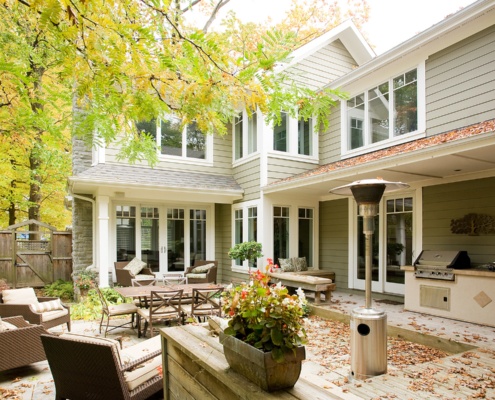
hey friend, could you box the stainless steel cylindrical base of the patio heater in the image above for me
[350,308,387,380]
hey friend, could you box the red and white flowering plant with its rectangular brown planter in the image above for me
[220,260,307,391]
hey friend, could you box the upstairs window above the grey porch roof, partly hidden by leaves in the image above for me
[136,116,209,160]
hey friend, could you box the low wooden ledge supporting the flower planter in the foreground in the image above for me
[160,325,340,400]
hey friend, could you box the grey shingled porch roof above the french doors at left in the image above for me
[71,164,243,193]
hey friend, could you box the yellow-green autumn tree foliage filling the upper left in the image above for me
[0,0,367,230]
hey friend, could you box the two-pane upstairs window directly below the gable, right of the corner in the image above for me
[273,112,317,156]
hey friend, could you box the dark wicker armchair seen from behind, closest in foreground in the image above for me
[41,333,163,400]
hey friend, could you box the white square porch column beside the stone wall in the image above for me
[95,196,110,287]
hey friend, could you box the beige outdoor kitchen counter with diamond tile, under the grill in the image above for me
[401,266,495,326]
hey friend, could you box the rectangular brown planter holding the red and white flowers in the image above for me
[220,332,306,392]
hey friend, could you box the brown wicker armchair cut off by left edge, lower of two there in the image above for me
[0,316,48,371]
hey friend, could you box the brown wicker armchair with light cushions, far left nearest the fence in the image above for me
[0,288,70,331]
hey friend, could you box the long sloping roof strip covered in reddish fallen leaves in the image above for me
[268,119,495,187]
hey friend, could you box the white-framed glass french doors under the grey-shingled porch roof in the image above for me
[115,205,208,272]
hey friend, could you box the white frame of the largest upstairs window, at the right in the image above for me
[340,61,426,158]
